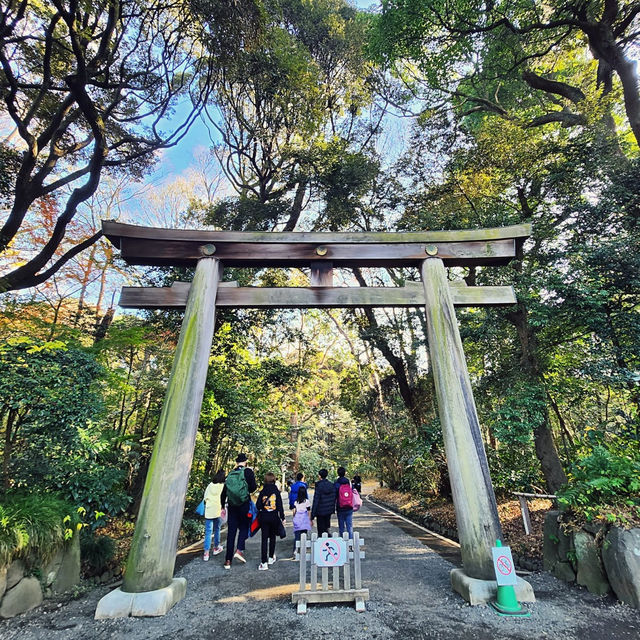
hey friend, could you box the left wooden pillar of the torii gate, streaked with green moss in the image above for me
[122,258,220,593]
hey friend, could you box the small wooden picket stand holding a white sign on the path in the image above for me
[291,531,369,615]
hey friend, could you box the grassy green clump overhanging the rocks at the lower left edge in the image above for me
[0,492,82,566]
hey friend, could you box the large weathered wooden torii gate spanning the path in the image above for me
[96,221,531,618]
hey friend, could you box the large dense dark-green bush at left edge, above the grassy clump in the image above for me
[0,337,130,527]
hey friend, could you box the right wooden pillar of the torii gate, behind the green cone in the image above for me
[422,258,502,580]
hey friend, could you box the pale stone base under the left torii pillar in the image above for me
[94,578,187,620]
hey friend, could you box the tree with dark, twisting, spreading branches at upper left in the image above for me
[0,0,254,292]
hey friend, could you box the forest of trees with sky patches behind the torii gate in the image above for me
[0,0,640,572]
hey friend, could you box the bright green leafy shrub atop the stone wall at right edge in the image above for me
[558,443,640,524]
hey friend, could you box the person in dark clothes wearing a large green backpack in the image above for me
[220,453,257,569]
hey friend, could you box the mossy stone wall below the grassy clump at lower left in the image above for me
[0,535,80,618]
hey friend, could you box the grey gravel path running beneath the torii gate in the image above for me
[0,501,640,640]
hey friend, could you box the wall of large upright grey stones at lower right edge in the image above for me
[543,511,640,609]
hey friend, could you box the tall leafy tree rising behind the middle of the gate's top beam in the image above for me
[202,0,382,231]
